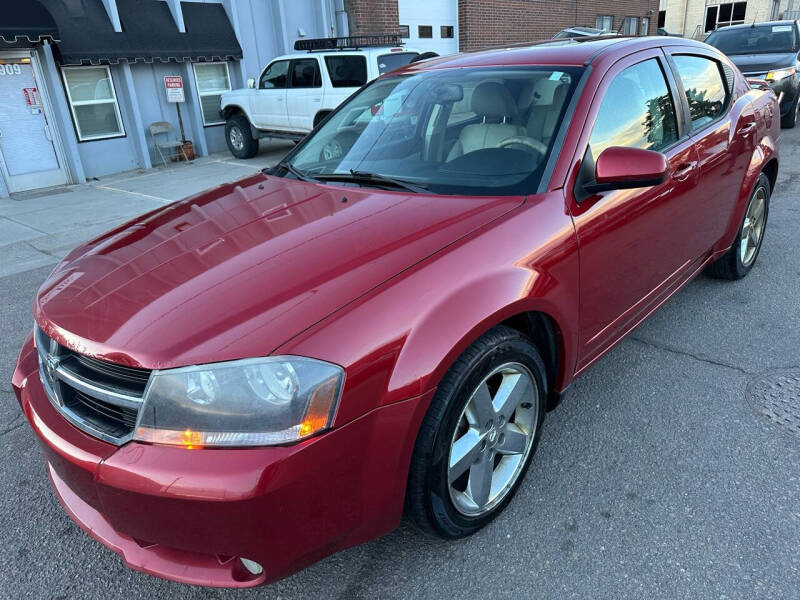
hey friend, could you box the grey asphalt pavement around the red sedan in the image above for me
[0,129,800,600]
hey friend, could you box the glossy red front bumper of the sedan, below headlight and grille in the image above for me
[12,338,433,587]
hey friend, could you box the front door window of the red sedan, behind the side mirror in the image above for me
[589,59,678,159]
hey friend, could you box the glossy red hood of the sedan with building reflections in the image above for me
[35,174,522,368]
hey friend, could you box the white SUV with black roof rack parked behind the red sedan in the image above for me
[220,36,419,158]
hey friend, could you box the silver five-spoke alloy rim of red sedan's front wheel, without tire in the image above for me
[447,363,540,517]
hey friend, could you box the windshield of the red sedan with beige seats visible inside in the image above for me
[278,67,581,195]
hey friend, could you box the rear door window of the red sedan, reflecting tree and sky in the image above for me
[672,56,728,131]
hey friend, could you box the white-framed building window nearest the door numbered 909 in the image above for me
[61,67,125,142]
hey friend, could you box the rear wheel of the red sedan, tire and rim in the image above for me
[707,173,770,279]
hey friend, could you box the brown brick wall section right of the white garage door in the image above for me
[458,0,658,51]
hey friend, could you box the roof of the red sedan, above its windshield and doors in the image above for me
[392,36,708,74]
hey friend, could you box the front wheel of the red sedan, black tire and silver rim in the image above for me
[406,326,547,538]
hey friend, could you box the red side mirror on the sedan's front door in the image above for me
[583,146,669,194]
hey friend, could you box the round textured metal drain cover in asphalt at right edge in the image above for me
[747,369,800,436]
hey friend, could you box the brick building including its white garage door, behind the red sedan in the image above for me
[344,0,659,53]
